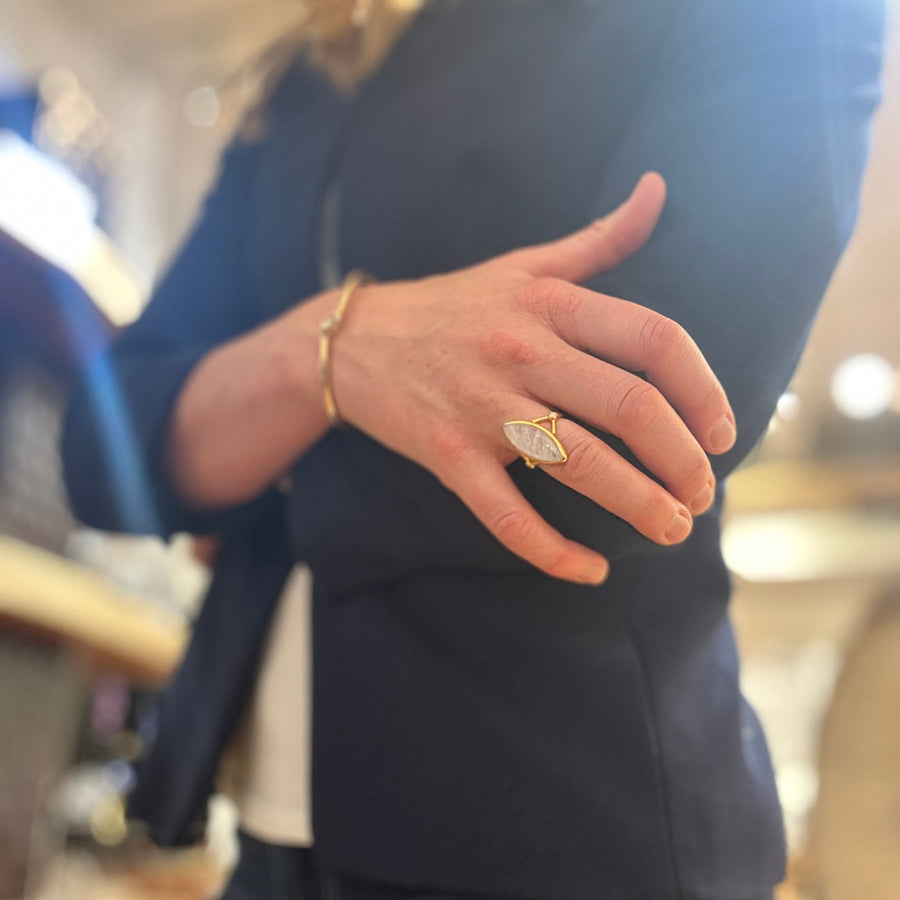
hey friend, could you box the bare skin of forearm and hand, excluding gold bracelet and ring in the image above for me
[167,173,735,583]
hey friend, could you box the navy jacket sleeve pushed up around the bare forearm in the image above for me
[62,142,280,536]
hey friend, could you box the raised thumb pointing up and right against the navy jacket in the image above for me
[507,172,666,284]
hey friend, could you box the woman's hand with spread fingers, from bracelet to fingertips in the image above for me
[326,173,735,583]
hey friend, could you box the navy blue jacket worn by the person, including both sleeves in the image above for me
[64,0,883,900]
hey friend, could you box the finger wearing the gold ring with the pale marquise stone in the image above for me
[500,401,693,546]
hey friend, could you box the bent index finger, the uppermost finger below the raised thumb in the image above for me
[533,281,737,453]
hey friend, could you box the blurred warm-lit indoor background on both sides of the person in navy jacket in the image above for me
[0,0,900,900]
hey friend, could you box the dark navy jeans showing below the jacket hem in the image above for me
[220,833,772,900]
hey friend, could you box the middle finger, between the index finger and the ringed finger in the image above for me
[525,342,715,512]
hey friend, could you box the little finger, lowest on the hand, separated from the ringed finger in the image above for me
[445,453,609,584]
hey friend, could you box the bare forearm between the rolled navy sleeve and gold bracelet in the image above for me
[165,292,335,509]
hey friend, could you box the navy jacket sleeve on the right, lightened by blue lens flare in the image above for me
[515,0,883,556]
